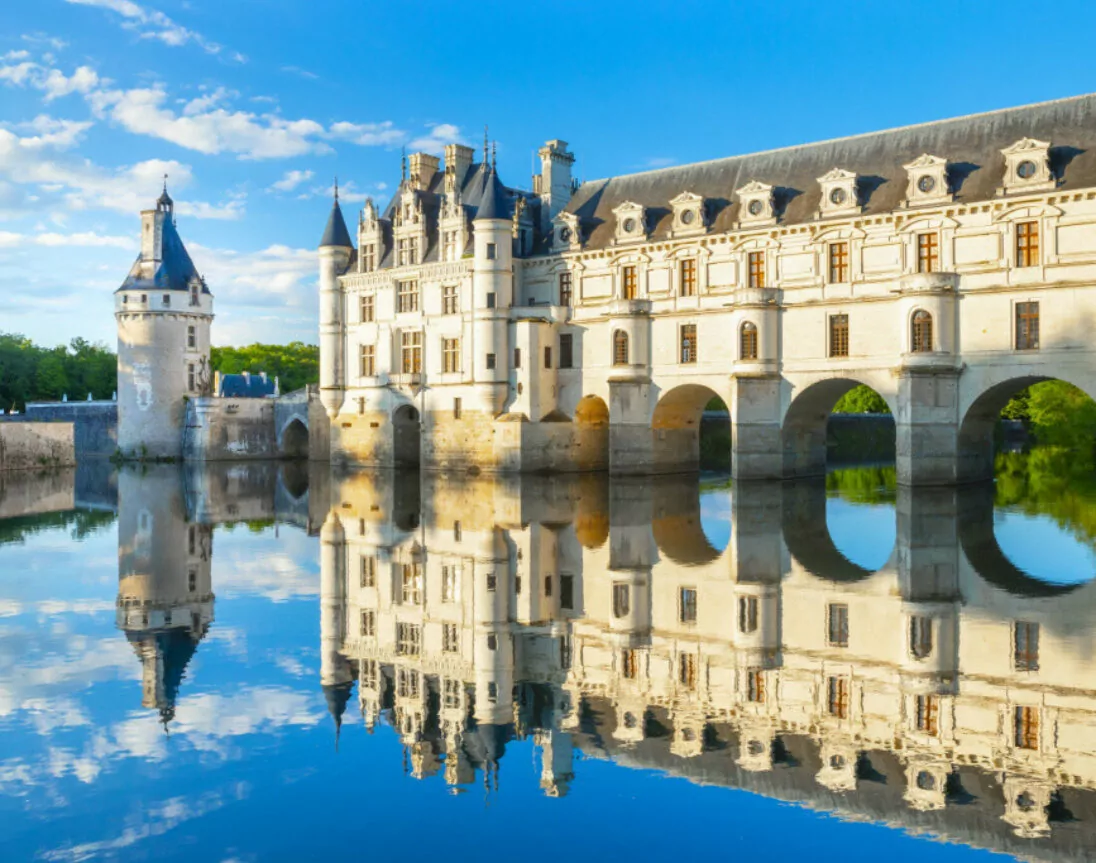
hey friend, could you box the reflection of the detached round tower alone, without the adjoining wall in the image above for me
[117,466,214,724]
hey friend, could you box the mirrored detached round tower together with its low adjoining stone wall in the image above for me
[116,464,320,727]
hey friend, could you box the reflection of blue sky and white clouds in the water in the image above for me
[0,475,1091,861]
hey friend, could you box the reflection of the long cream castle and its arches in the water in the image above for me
[321,475,1096,860]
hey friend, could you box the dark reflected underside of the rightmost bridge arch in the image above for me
[958,482,1093,599]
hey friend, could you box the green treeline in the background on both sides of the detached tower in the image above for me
[0,332,320,411]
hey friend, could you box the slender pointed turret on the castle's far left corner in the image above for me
[320,184,354,419]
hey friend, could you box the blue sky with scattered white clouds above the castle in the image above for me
[0,0,1096,347]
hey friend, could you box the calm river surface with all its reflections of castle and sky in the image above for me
[0,453,1096,863]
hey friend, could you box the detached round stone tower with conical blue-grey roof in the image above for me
[114,184,213,458]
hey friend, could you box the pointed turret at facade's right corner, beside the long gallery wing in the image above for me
[472,164,514,413]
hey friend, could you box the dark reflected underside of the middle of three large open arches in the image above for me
[780,479,894,583]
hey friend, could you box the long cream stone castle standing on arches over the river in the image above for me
[319,95,1096,484]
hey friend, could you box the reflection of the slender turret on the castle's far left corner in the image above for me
[320,512,354,743]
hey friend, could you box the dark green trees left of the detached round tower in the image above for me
[0,332,118,410]
